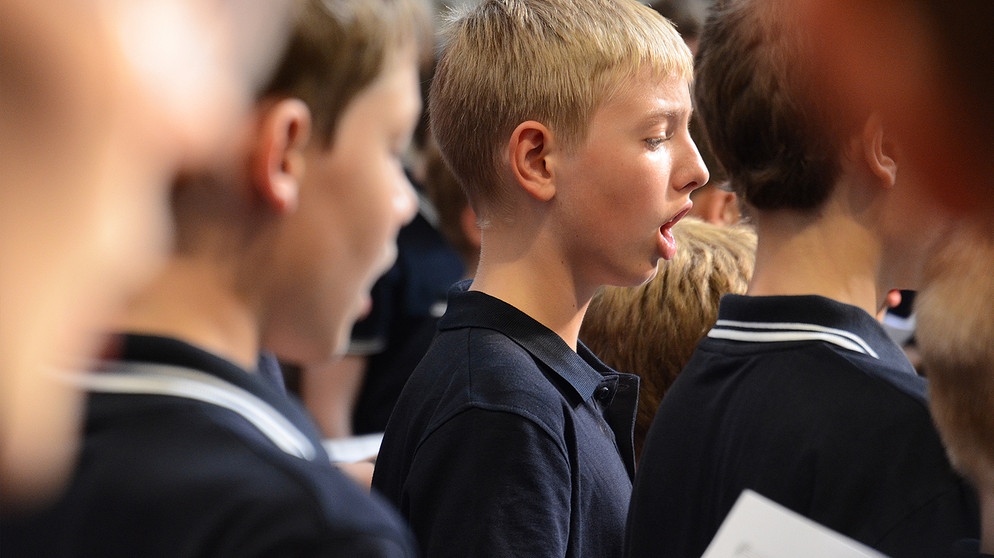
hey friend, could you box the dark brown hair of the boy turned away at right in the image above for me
[694,0,855,210]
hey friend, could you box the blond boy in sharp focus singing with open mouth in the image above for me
[373,0,708,557]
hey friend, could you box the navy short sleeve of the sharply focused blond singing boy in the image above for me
[403,408,573,557]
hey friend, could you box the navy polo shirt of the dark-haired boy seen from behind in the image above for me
[627,295,979,558]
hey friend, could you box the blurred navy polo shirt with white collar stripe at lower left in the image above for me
[2,336,416,557]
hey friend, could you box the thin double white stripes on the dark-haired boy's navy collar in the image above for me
[708,320,880,359]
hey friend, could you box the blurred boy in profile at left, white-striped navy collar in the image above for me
[3,0,426,557]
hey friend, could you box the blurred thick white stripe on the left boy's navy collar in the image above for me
[65,362,317,461]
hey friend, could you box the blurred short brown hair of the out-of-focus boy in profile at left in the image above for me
[262,0,434,147]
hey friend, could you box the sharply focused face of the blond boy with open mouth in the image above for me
[553,71,708,294]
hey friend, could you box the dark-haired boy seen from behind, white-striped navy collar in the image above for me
[629,0,978,557]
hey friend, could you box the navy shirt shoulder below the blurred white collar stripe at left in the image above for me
[16,370,413,556]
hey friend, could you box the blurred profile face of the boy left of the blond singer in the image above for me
[271,52,421,364]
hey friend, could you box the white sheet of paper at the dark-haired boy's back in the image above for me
[702,490,886,558]
